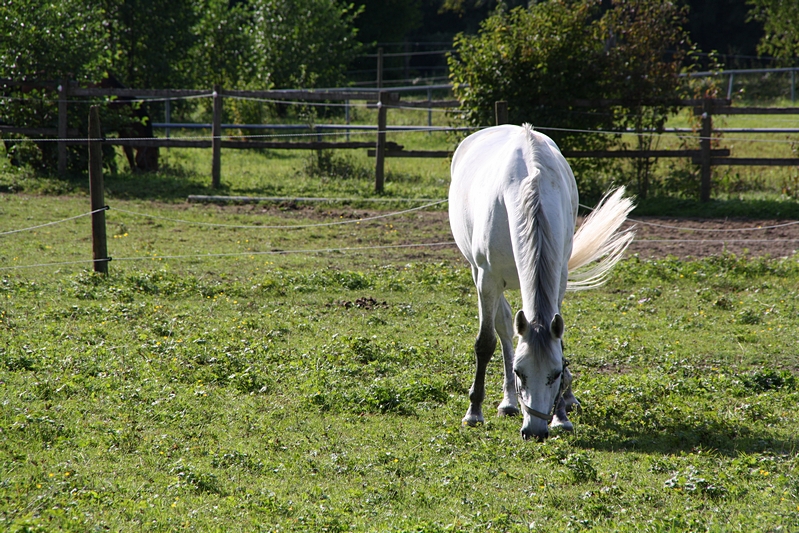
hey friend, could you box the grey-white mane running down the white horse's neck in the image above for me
[518,124,559,343]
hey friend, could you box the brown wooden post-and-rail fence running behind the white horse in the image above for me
[0,80,799,201]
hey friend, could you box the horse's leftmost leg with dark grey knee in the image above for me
[463,271,497,426]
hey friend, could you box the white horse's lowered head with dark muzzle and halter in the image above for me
[513,311,564,440]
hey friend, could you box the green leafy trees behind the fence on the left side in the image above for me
[0,0,358,171]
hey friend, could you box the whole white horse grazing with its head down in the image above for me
[449,124,634,440]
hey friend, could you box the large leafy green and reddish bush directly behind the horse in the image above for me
[449,0,689,196]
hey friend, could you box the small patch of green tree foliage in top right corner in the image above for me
[748,0,799,61]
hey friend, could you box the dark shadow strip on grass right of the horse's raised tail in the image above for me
[632,198,799,219]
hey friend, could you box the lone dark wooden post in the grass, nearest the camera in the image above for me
[89,105,111,274]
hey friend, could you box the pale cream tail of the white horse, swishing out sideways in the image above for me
[566,187,635,291]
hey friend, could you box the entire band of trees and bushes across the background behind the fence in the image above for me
[0,0,799,202]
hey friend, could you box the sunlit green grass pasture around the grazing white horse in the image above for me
[0,192,799,533]
